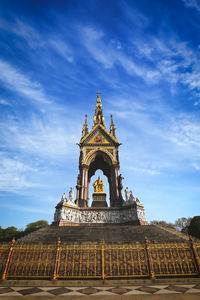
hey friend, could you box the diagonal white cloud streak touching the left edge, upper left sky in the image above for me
[0,59,50,104]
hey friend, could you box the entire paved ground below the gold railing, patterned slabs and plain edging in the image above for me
[0,278,200,300]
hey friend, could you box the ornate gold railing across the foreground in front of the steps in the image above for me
[0,240,200,280]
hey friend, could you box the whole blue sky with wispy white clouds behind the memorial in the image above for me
[0,0,200,228]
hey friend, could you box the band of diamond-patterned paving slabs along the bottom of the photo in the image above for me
[0,283,200,299]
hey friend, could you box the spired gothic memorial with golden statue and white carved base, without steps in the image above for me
[53,92,147,226]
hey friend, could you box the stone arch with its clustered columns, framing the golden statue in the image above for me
[76,149,122,207]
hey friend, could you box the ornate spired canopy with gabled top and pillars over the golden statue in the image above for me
[76,92,123,207]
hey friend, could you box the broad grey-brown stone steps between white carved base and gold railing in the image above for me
[18,225,187,243]
